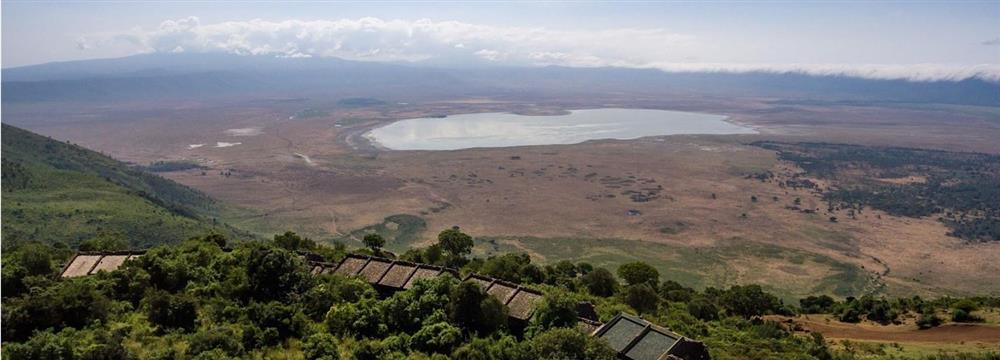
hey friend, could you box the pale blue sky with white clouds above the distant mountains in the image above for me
[0,0,1000,80]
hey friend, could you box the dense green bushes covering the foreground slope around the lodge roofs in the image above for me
[2,230,1000,360]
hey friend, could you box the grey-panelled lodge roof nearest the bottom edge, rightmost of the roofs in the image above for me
[593,313,709,360]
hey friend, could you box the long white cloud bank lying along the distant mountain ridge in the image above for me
[78,17,1000,81]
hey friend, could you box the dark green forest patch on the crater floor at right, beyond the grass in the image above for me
[754,141,1000,241]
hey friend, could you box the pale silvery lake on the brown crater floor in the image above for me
[365,109,756,150]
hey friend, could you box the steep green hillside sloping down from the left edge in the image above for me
[2,124,245,247]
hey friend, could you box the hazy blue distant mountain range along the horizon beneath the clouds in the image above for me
[3,54,1000,106]
